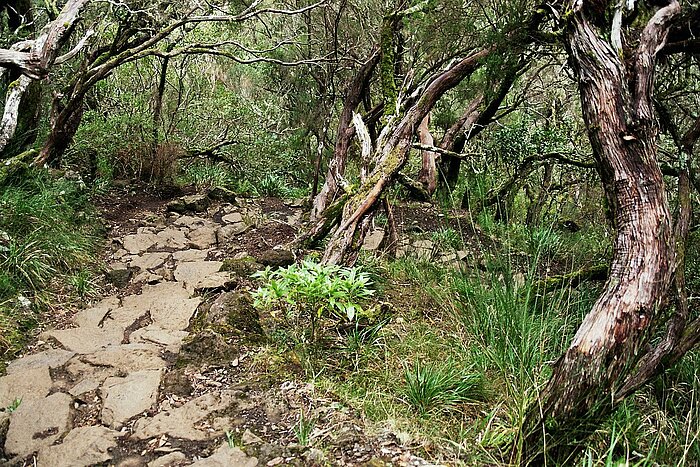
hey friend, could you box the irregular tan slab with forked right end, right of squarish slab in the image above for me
[132,391,235,441]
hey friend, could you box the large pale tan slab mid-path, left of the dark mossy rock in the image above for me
[123,282,201,331]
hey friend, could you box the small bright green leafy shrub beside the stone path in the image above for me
[253,261,374,341]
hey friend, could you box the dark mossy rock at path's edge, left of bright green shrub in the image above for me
[207,292,265,343]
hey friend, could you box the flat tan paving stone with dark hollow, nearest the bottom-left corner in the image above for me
[5,392,73,457]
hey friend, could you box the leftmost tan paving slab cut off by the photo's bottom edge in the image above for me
[37,426,125,467]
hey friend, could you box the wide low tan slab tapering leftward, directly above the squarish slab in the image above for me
[80,344,167,373]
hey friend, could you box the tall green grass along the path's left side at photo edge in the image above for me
[0,170,99,356]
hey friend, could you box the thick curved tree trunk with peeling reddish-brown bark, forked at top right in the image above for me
[514,0,680,464]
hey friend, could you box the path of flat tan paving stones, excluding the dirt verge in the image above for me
[0,192,276,467]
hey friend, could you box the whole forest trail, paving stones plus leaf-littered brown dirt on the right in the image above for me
[0,191,438,467]
